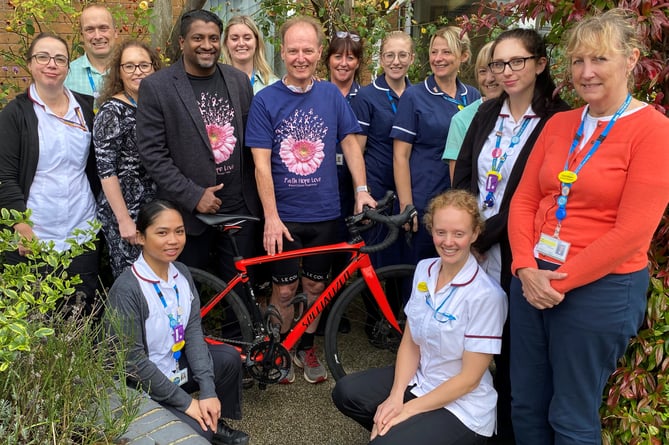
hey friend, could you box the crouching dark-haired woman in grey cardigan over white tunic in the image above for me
[107,200,249,445]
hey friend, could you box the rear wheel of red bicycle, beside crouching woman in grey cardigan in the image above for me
[189,267,254,345]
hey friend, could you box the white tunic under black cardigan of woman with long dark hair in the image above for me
[478,99,540,283]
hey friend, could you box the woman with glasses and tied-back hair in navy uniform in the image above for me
[351,31,414,267]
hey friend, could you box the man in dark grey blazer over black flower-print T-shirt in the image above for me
[137,10,261,288]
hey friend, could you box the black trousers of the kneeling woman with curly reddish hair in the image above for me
[332,366,487,445]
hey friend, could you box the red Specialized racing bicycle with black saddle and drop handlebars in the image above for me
[190,192,416,388]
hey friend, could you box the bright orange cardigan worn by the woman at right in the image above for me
[509,106,669,293]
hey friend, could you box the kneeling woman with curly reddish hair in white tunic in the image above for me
[332,190,507,445]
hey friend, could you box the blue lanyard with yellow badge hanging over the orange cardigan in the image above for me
[553,93,632,234]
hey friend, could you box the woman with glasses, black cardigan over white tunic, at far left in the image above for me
[0,33,100,311]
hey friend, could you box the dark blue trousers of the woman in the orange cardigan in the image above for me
[510,261,648,445]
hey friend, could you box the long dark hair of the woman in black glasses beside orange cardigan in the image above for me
[490,28,561,117]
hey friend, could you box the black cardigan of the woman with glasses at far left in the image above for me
[0,91,101,212]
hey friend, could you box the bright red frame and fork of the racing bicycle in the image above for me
[200,236,401,350]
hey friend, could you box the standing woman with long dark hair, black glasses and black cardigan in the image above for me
[453,29,568,440]
